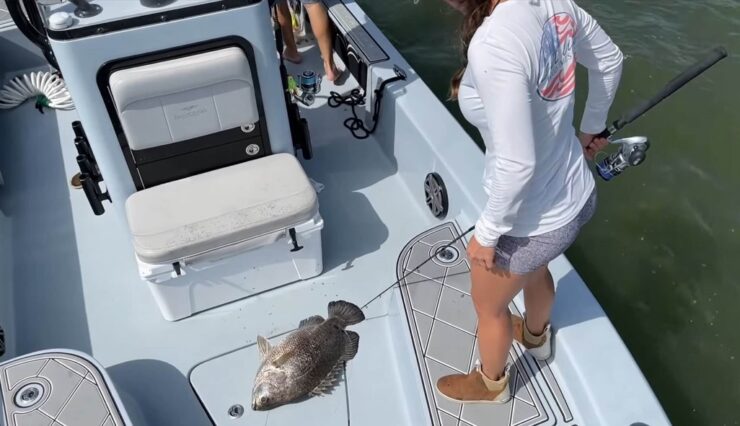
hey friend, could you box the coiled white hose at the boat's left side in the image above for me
[0,71,75,110]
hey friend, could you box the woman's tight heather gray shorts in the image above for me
[495,189,597,275]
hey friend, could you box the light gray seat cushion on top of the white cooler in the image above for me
[126,154,318,264]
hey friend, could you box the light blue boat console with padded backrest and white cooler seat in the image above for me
[21,0,336,320]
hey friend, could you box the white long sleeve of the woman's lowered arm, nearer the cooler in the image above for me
[469,40,535,251]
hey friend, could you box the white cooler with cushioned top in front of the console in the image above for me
[126,154,323,321]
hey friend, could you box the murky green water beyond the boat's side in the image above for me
[361,0,740,425]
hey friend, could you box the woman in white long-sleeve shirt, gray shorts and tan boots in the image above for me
[437,0,622,403]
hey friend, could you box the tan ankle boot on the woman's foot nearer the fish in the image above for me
[437,365,511,404]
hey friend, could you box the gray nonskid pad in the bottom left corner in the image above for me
[0,353,124,426]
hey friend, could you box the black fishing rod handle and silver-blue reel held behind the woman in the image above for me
[596,46,727,182]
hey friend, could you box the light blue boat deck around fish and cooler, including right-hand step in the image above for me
[0,2,663,426]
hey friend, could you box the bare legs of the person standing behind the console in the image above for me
[276,0,340,81]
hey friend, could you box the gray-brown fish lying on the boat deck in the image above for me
[252,300,365,411]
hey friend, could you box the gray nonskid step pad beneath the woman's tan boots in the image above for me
[396,223,574,426]
